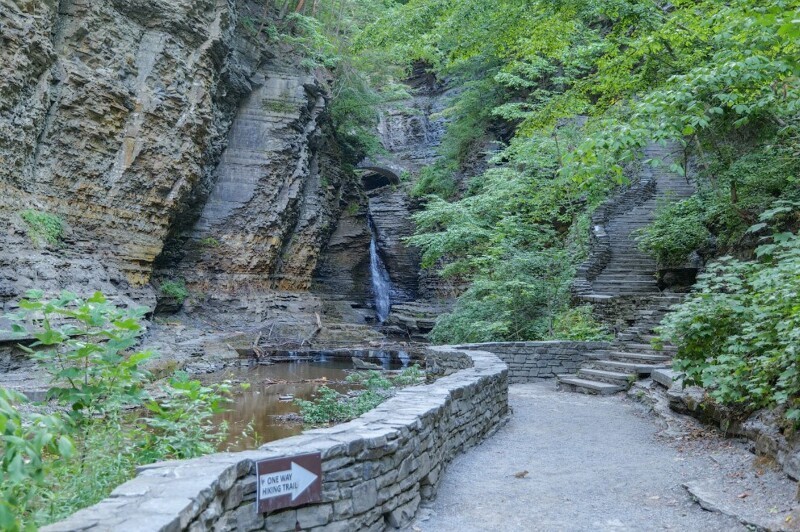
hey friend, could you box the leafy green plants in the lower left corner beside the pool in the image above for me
[0,291,228,530]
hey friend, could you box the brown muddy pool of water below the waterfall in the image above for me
[209,351,419,451]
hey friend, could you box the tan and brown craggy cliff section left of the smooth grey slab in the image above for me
[0,0,250,300]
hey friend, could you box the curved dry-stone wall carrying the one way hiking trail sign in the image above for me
[44,347,509,532]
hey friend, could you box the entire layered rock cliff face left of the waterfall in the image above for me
[0,0,366,314]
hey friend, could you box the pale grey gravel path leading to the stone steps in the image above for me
[409,383,794,532]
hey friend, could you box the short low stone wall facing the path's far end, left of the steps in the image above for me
[458,340,611,384]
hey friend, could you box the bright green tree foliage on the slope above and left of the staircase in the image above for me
[358,0,800,341]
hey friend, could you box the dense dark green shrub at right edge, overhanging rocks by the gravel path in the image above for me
[660,228,800,423]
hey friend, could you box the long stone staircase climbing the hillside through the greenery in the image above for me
[558,145,695,395]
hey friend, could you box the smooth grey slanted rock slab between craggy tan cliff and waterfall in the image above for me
[165,64,366,291]
